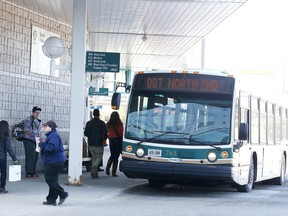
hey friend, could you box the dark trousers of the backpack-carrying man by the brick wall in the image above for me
[23,140,38,175]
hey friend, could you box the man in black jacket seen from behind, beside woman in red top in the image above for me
[84,109,108,178]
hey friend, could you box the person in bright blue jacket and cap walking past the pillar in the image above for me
[39,121,69,206]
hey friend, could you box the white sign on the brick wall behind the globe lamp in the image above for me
[30,26,60,77]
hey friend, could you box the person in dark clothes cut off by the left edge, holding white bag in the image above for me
[0,120,18,194]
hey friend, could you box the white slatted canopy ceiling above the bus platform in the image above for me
[3,0,248,69]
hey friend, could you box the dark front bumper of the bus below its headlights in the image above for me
[120,159,234,183]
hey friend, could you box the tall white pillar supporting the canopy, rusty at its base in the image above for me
[68,0,87,185]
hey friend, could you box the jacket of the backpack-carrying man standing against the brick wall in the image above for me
[24,115,41,142]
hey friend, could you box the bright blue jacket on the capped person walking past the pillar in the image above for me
[39,130,66,167]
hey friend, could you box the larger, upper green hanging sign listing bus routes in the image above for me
[86,51,120,73]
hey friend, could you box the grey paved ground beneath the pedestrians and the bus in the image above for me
[0,148,288,216]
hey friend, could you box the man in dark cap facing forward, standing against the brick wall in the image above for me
[23,106,42,179]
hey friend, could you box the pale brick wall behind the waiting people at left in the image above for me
[0,1,72,172]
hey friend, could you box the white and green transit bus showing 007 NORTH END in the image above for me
[120,71,288,192]
